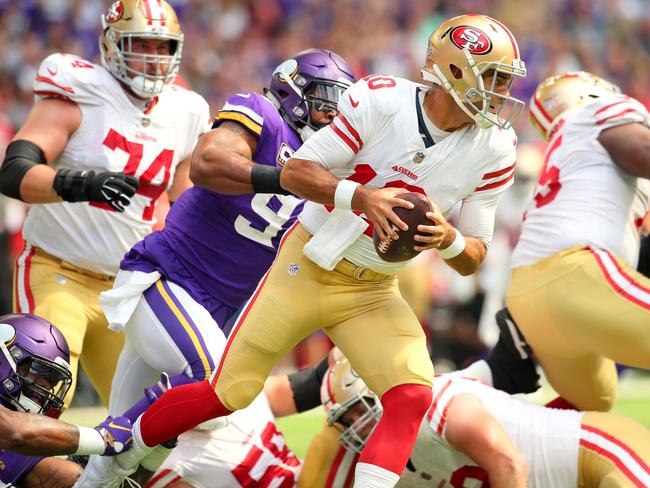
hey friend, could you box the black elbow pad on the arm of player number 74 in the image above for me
[0,140,47,200]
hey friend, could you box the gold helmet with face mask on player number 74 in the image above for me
[99,0,183,98]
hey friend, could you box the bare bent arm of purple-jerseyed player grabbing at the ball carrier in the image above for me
[190,120,260,195]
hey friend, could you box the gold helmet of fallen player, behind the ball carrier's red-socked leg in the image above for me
[320,357,382,453]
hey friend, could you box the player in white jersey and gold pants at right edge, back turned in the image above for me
[506,72,650,411]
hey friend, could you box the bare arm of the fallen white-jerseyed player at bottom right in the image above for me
[446,393,528,488]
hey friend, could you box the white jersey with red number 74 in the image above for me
[23,54,210,275]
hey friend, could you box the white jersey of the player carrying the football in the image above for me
[294,75,517,274]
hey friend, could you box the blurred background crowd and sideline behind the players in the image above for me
[0,0,650,382]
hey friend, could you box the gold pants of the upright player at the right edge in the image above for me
[506,247,650,411]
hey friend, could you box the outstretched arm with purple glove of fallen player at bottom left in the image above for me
[0,407,132,456]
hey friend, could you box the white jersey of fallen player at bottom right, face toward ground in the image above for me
[397,375,582,488]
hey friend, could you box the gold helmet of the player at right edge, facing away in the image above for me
[529,71,621,139]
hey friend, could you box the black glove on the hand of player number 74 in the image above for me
[52,169,138,212]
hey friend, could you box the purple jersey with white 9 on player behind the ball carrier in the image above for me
[120,92,303,327]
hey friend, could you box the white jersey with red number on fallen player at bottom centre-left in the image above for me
[147,393,302,488]
